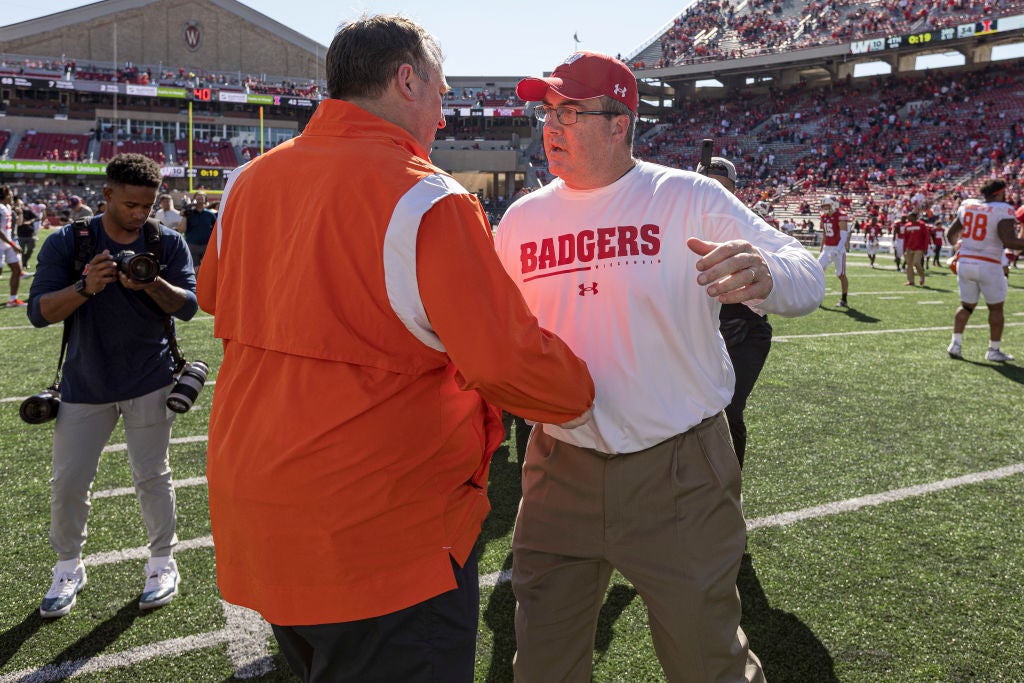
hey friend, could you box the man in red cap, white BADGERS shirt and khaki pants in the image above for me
[496,52,824,682]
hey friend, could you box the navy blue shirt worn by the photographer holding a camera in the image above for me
[28,216,199,403]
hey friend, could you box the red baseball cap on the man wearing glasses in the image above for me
[515,51,640,114]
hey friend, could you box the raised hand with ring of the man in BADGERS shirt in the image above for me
[686,238,772,303]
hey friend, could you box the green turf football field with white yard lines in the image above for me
[0,246,1024,683]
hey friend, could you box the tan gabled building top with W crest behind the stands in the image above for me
[0,0,327,77]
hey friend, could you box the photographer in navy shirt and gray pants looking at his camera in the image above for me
[29,154,198,617]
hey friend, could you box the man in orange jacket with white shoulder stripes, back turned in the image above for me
[199,16,594,682]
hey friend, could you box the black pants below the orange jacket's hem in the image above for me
[273,550,480,683]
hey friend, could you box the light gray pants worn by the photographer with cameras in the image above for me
[50,384,178,560]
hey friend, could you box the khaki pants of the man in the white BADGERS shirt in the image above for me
[512,414,764,683]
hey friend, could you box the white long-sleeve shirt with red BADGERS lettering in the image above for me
[496,162,825,453]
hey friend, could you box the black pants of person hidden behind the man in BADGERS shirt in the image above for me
[722,317,771,467]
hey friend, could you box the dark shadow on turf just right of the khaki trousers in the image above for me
[736,553,839,683]
